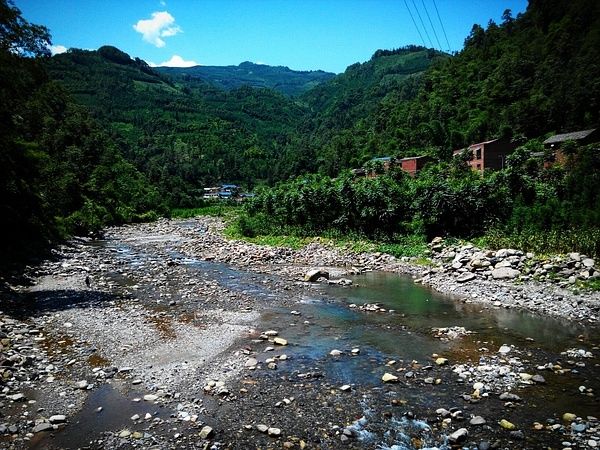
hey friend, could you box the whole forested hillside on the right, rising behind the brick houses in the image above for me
[296,0,600,171]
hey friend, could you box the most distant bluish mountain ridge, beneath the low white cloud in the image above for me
[156,61,335,96]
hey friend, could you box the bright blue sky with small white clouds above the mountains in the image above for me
[15,0,527,73]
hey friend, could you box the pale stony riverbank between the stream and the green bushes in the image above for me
[159,218,600,324]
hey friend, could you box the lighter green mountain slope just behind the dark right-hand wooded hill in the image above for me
[272,46,448,176]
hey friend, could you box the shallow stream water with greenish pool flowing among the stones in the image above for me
[31,239,600,449]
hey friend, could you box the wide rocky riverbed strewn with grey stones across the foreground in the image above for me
[0,218,600,449]
